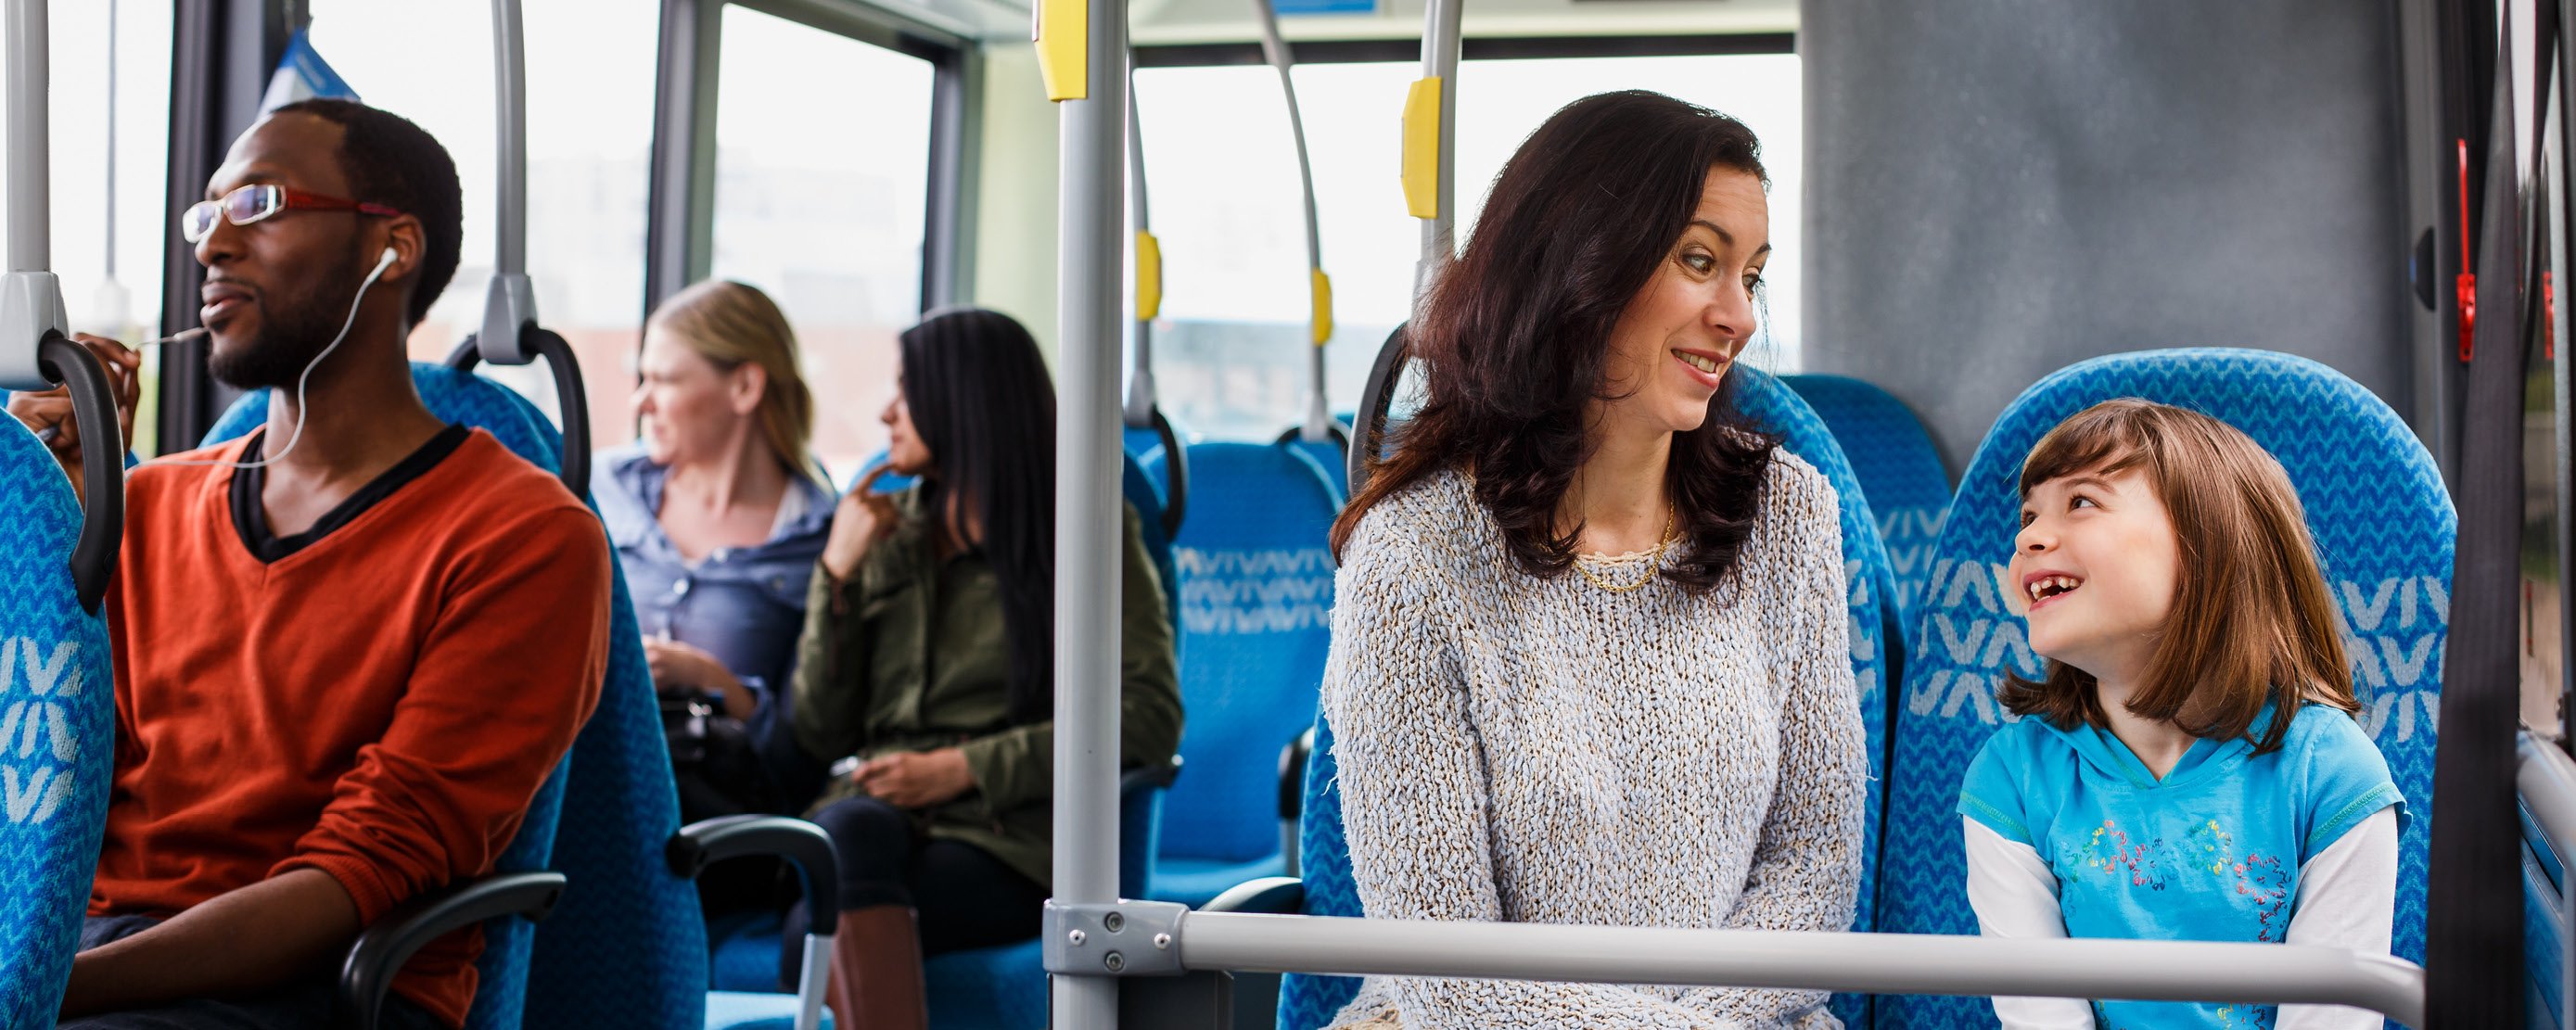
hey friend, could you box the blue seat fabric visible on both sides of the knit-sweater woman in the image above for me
[1278,365,1894,1030]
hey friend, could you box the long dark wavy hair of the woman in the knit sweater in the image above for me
[1332,90,1775,592]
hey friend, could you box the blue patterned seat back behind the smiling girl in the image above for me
[1878,348,2457,1027]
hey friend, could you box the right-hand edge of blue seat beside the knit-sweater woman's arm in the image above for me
[1726,365,1904,1024]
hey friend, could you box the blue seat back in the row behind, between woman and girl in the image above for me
[1780,376,1950,643]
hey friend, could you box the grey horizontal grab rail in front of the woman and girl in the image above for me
[1180,911,2424,1027]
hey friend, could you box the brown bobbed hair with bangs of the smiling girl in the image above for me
[1999,400,2360,755]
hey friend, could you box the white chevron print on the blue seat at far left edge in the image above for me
[0,636,83,824]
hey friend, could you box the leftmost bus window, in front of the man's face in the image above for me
[0,0,174,456]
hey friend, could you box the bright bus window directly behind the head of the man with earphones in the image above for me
[309,0,659,448]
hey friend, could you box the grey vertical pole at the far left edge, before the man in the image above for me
[0,0,64,388]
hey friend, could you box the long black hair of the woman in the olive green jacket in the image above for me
[901,309,1056,723]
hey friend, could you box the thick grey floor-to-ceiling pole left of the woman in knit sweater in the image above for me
[1040,0,1129,1030]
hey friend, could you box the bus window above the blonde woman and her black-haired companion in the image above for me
[711,6,942,481]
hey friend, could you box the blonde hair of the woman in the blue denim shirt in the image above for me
[644,278,822,479]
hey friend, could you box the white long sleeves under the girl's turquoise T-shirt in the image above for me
[1960,806,2398,1030]
